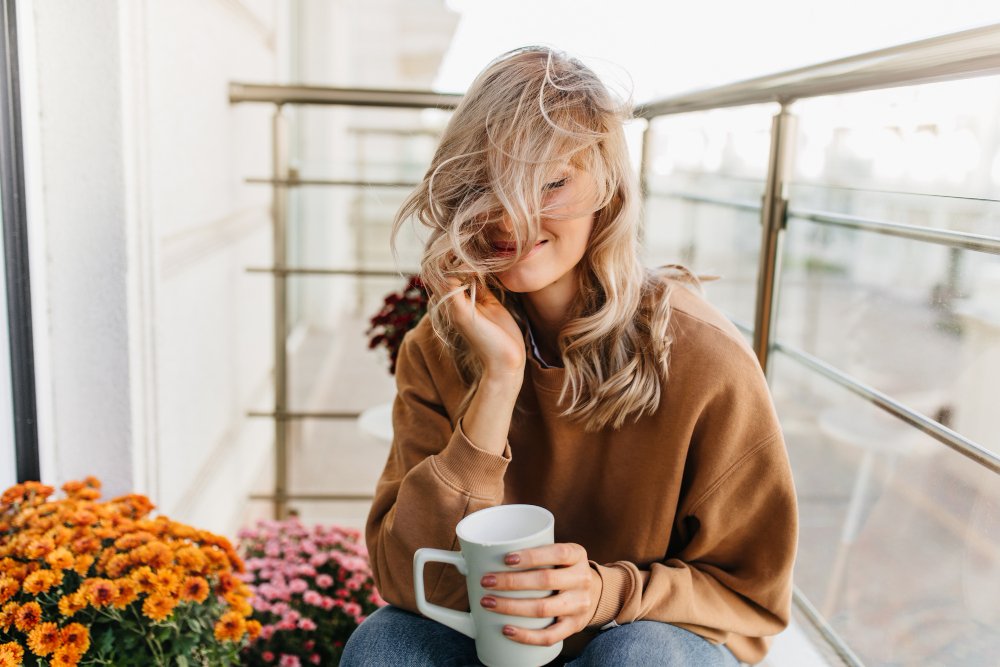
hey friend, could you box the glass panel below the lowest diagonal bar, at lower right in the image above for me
[771,353,1000,667]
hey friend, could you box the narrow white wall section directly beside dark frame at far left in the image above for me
[18,0,133,492]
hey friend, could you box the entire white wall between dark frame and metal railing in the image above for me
[19,0,288,531]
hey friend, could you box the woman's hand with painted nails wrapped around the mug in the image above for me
[480,544,603,646]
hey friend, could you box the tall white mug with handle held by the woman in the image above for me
[413,505,562,667]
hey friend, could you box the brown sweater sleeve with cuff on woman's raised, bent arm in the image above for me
[365,331,510,611]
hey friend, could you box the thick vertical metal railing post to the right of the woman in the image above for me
[753,104,795,376]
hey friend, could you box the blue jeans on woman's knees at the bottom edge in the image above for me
[340,607,739,667]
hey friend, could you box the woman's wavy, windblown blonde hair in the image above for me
[392,47,697,431]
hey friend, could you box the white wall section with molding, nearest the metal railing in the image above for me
[144,0,287,530]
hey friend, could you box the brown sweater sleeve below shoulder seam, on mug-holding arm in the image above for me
[590,431,798,661]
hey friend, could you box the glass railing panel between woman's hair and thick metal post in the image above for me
[643,105,776,332]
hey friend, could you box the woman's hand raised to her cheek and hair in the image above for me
[443,278,525,386]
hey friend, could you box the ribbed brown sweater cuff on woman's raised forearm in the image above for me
[433,420,510,499]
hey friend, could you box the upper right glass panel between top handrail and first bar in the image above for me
[790,76,1000,236]
